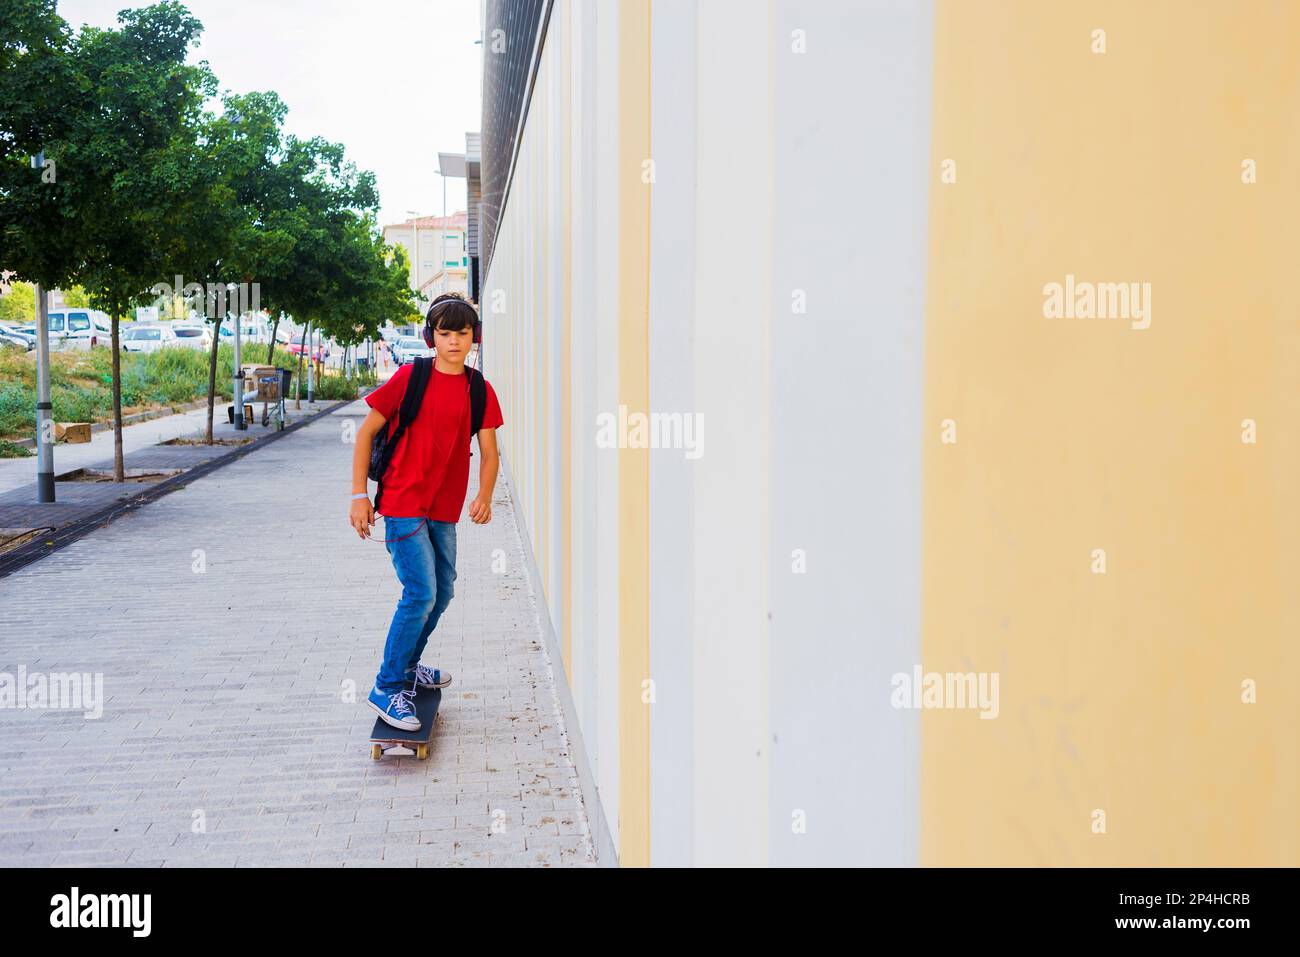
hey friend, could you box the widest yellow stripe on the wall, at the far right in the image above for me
[922,0,1300,866]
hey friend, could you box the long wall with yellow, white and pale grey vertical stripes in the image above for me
[482,0,1300,866]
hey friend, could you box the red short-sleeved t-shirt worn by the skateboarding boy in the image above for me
[365,363,502,521]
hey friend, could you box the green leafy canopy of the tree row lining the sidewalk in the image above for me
[0,0,415,467]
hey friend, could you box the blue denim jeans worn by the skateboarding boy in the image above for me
[374,516,456,694]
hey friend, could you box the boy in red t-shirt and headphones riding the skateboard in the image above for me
[348,293,502,731]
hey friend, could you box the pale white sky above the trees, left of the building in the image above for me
[59,0,481,222]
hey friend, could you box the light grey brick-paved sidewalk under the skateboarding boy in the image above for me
[0,402,594,866]
